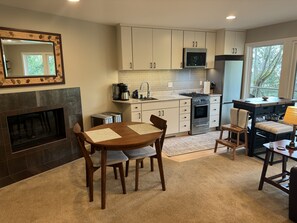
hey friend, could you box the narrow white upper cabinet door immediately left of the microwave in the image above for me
[171,30,184,69]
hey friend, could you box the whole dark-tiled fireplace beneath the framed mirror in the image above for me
[0,88,82,187]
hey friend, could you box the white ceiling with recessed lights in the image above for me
[0,0,297,29]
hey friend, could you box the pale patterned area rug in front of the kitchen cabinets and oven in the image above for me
[162,131,225,157]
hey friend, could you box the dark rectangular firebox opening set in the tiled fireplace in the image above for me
[7,108,66,153]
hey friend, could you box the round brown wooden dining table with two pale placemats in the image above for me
[85,122,166,209]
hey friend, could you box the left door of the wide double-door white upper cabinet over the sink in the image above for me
[132,27,153,70]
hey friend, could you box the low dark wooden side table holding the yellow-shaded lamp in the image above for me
[258,139,297,193]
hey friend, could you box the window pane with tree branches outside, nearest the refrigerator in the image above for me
[249,45,283,97]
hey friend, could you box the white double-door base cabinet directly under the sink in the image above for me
[142,100,179,134]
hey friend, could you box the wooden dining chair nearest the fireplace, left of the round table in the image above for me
[73,123,128,202]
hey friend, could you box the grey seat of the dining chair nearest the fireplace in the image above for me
[90,150,128,167]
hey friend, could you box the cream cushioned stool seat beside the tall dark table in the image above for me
[255,121,293,135]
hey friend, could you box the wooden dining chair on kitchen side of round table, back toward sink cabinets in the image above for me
[123,115,167,191]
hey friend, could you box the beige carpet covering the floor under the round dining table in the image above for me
[0,149,290,223]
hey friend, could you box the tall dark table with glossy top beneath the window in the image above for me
[233,97,296,156]
